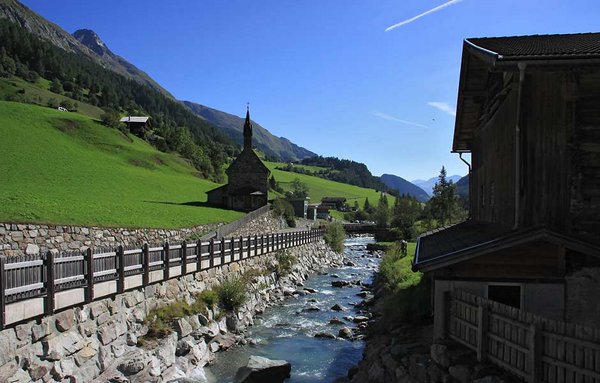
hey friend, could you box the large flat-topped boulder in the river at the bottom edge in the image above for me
[235,355,292,383]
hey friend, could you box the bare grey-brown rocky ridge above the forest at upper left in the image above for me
[0,0,173,98]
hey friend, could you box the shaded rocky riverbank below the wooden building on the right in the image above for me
[346,260,519,383]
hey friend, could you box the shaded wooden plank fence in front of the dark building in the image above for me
[446,290,600,383]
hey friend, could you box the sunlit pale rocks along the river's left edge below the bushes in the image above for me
[86,242,343,383]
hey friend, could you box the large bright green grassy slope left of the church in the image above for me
[0,101,242,228]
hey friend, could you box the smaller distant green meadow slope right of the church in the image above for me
[265,161,394,208]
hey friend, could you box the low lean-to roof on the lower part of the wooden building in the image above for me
[413,221,600,271]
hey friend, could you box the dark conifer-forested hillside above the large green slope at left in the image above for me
[0,19,237,180]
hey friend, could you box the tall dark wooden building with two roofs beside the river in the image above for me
[413,33,600,340]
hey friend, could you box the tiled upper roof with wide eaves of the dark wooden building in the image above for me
[452,33,600,152]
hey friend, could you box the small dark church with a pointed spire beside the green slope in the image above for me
[207,109,271,211]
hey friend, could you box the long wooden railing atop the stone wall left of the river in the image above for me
[0,230,323,329]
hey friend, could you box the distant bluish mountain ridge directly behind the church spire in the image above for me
[184,101,316,162]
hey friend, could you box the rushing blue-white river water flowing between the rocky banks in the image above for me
[206,237,379,383]
